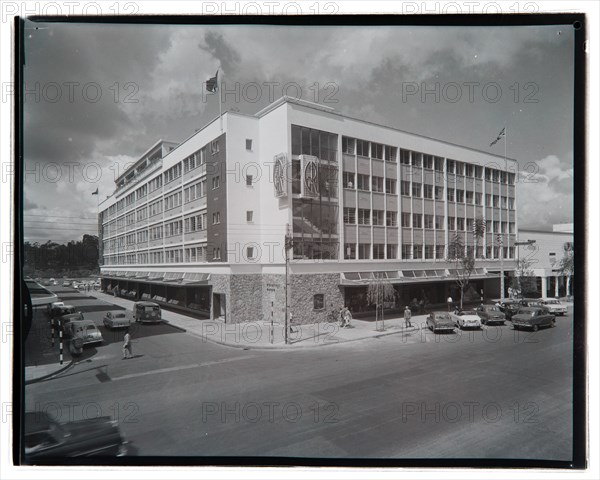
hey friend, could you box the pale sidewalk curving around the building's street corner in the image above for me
[89,292,426,350]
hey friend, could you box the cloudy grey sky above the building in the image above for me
[24,22,574,243]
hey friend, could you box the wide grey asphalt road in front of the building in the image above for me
[25,288,572,460]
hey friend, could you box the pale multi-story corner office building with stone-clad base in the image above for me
[99,97,517,323]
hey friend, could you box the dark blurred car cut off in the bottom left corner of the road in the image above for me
[24,412,128,463]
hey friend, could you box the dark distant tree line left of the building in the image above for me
[23,235,99,276]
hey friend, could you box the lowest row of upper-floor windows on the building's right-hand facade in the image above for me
[344,243,515,260]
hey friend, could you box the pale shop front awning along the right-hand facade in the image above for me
[340,268,499,286]
